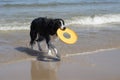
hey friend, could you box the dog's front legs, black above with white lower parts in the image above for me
[46,36,57,56]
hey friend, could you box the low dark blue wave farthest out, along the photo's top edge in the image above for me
[2,1,120,7]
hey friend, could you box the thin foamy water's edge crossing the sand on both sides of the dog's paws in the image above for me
[0,48,120,66]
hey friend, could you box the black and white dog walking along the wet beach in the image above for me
[30,17,65,55]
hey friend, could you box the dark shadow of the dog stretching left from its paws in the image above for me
[15,47,60,62]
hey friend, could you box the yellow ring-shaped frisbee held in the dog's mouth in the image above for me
[57,28,78,44]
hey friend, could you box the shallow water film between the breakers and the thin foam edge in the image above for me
[0,28,120,63]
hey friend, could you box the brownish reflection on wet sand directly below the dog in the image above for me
[31,61,60,80]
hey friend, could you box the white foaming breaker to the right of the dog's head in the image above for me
[66,14,120,25]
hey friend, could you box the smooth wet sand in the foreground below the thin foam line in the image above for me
[0,49,120,80]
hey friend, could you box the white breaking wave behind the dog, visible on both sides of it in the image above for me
[0,14,120,30]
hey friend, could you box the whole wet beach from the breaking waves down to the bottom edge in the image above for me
[0,28,120,80]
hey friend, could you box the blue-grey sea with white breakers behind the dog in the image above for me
[0,0,120,31]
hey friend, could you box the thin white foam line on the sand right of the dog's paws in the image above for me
[63,48,118,57]
